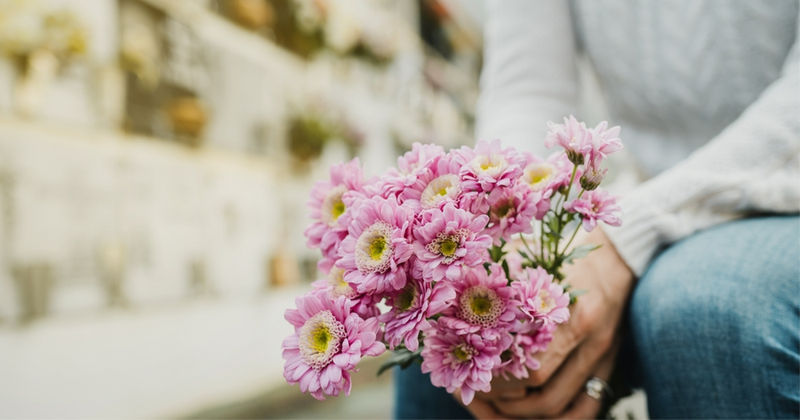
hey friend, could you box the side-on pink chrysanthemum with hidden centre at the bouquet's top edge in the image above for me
[380,143,445,198]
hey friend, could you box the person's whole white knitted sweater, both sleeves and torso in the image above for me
[477,0,800,275]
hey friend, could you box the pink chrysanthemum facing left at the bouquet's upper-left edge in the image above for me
[305,158,364,273]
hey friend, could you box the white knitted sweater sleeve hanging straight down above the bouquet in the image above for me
[476,0,578,156]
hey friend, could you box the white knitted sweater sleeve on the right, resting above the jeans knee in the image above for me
[604,17,800,275]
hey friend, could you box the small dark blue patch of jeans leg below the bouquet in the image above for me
[393,365,473,420]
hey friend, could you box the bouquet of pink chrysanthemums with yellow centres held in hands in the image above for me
[283,117,622,404]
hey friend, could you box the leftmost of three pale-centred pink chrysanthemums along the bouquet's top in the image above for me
[398,153,462,211]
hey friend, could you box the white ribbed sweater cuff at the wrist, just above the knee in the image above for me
[603,200,664,277]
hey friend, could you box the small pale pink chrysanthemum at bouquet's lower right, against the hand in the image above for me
[510,267,569,325]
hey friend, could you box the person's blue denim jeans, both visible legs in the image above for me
[395,216,800,420]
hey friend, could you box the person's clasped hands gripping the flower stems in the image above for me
[460,228,634,420]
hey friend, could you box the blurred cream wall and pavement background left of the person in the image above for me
[0,0,482,420]
